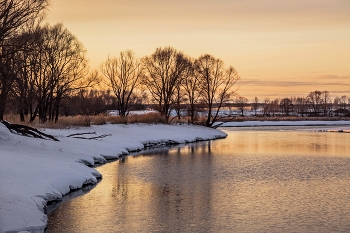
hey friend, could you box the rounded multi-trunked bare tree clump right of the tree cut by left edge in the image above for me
[14,24,91,123]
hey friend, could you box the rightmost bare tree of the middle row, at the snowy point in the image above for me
[194,54,240,127]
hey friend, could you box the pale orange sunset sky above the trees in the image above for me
[47,0,350,101]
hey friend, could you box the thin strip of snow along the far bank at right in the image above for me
[216,121,350,127]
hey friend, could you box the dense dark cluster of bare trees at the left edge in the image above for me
[0,0,98,122]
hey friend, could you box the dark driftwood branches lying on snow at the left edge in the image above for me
[1,121,59,141]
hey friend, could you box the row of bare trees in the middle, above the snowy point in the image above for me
[100,47,239,126]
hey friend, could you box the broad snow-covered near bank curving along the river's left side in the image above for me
[0,123,226,232]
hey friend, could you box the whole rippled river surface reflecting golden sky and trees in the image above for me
[48,127,350,232]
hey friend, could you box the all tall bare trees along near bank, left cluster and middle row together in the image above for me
[0,0,243,126]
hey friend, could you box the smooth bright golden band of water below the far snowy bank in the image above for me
[219,131,350,157]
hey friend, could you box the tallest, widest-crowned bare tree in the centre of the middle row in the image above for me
[142,47,191,121]
